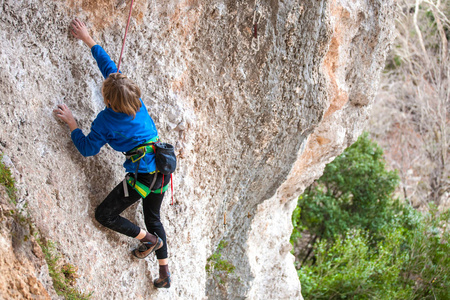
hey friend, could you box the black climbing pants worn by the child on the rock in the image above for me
[95,173,170,259]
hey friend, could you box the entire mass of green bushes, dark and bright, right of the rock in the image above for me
[291,134,450,300]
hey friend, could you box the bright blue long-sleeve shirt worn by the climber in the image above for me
[71,45,158,173]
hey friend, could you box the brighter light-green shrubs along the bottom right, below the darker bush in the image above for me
[298,208,450,300]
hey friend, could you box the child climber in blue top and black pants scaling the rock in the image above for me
[54,19,170,288]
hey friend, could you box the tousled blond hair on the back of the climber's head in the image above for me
[102,73,142,119]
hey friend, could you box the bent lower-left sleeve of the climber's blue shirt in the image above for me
[71,120,107,157]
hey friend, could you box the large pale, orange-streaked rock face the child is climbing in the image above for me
[0,0,393,299]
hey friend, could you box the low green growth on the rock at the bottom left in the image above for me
[38,239,92,300]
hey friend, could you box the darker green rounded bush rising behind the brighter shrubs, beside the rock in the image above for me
[293,133,402,243]
